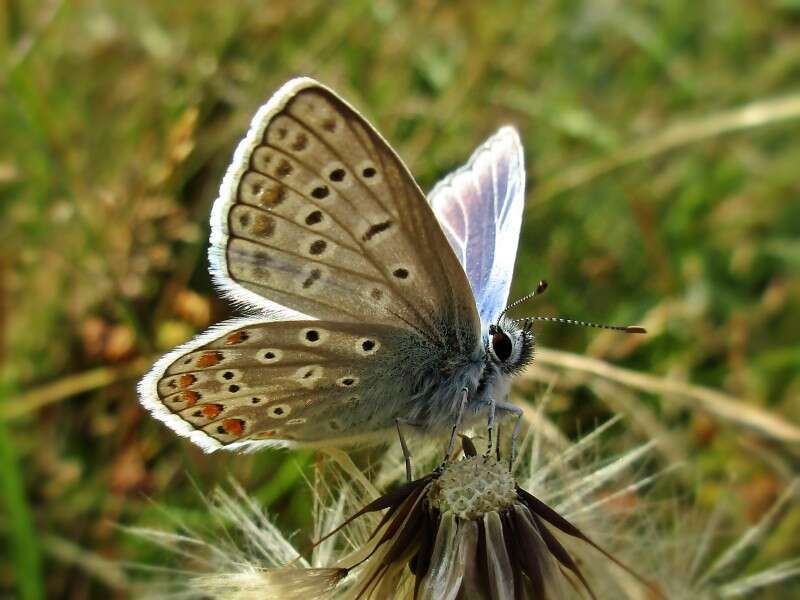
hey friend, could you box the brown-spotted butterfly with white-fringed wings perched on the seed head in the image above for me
[138,78,644,452]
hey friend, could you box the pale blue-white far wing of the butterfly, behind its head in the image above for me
[429,127,525,326]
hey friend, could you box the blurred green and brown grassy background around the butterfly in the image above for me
[0,0,800,598]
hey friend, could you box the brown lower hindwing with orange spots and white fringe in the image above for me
[140,319,406,451]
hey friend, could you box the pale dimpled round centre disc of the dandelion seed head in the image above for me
[428,456,517,519]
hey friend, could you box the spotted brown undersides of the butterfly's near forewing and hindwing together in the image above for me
[139,78,480,451]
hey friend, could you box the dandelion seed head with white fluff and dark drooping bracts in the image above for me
[128,421,800,600]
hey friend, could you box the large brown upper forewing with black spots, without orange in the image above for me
[212,80,479,335]
